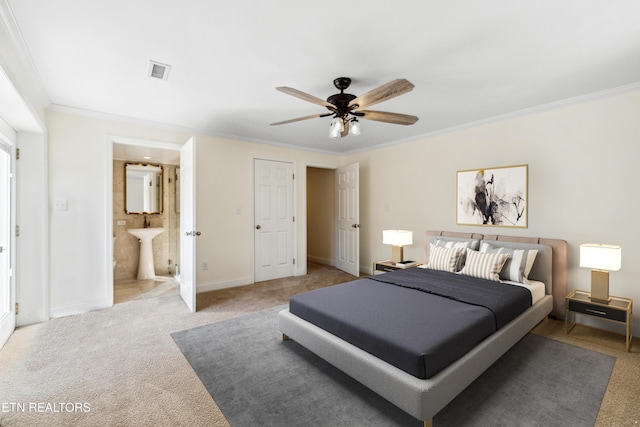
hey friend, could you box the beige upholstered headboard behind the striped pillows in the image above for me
[424,230,568,319]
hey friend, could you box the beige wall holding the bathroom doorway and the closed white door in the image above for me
[47,107,340,317]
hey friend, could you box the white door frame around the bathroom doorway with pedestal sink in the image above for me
[104,135,182,307]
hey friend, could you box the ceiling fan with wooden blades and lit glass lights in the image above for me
[271,77,418,138]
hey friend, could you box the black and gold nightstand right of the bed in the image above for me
[564,290,633,351]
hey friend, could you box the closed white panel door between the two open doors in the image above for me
[253,159,295,282]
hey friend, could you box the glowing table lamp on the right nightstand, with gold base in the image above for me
[580,243,622,304]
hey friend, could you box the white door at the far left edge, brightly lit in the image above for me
[0,141,16,348]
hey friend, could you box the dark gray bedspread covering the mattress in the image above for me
[289,268,531,378]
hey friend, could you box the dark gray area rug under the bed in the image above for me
[171,306,615,427]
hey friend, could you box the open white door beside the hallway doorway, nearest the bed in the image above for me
[336,163,360,277]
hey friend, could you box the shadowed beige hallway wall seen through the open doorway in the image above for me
[307,167,336,265]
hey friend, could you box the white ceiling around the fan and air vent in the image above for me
[1,0,640,153]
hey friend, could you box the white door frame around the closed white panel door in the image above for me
[249,155,298,283]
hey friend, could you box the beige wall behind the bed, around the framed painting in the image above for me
[347,90,640,330]
